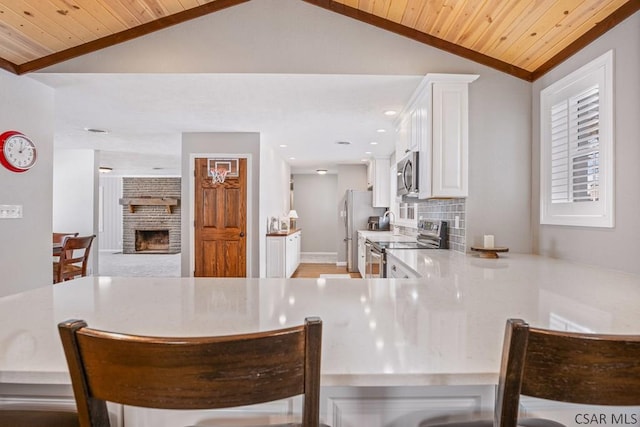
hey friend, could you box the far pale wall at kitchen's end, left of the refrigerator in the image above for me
[293,174,338,253]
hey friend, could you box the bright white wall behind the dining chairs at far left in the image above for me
[52,150,100,275]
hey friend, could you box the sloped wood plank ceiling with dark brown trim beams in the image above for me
[0,0,640,81]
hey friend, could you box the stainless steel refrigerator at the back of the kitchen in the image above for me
[343,190,386,272]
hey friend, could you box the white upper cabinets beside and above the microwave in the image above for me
[396,74,478,199]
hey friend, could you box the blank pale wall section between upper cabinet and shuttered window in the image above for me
[465,73,532,253]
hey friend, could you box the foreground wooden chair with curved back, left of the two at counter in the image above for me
[58,317,330,427]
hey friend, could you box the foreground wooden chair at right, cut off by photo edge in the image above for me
[420,319,640,427]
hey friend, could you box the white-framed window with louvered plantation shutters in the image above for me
[540,51,614,227]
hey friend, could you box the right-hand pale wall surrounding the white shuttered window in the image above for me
[532,12,640,276]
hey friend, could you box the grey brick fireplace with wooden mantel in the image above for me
[120,177,181,254]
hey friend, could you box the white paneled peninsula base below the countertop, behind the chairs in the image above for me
[11,383,639,427]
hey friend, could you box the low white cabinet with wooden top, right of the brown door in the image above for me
[267,230,302,278]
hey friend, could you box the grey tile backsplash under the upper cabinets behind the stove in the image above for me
[418,199,467,253]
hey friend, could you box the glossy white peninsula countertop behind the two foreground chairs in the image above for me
[0,254,640,387]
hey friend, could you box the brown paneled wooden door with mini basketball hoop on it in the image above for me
[194,159,247,277]
